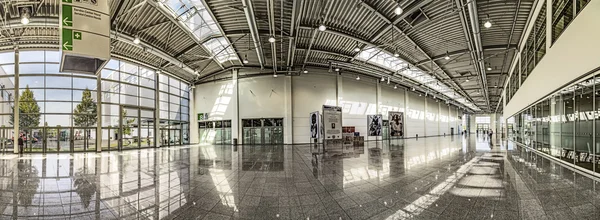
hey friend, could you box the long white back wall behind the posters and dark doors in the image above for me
[196,70,460,144]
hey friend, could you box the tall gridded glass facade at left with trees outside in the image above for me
[0,51,189,152]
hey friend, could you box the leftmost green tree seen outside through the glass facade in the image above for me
[9,86,41,152]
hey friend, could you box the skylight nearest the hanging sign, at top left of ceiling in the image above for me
[164,0,238,63]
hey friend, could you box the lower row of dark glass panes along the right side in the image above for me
[507,73,600,172]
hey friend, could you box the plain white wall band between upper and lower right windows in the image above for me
[504,1,600,118]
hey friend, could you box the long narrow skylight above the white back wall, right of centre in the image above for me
[358,48,480,111]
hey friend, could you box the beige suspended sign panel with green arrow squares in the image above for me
[60,0,110,74]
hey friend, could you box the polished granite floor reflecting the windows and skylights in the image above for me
[0,135,600,220]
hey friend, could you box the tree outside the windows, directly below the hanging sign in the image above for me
[73,88,98,150]
